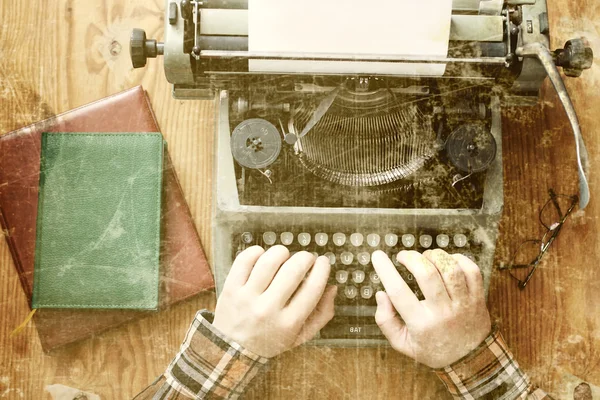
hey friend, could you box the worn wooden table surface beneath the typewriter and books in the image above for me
[0,0,600,399]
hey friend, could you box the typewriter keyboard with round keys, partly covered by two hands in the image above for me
[233,231,480,339]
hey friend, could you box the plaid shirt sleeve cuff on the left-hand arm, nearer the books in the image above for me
[135,310,268,400]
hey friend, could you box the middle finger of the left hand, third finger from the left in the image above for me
[264,251,315,308]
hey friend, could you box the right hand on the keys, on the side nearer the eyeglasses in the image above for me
[372,249,491,368]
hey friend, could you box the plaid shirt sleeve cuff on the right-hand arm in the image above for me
[435,329,552,400]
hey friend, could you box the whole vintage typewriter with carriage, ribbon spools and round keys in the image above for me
[131,0,593,346]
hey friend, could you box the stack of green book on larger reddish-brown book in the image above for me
[0,86,214,351]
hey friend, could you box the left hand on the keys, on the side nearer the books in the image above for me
[213,246,337,358]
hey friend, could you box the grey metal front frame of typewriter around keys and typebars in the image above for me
[212,90,503,347]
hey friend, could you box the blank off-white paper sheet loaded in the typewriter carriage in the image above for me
[248,0,452,76]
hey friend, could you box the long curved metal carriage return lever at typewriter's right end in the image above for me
[515,43,590,210]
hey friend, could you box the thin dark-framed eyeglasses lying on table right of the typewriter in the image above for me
[498,189,579,290]
